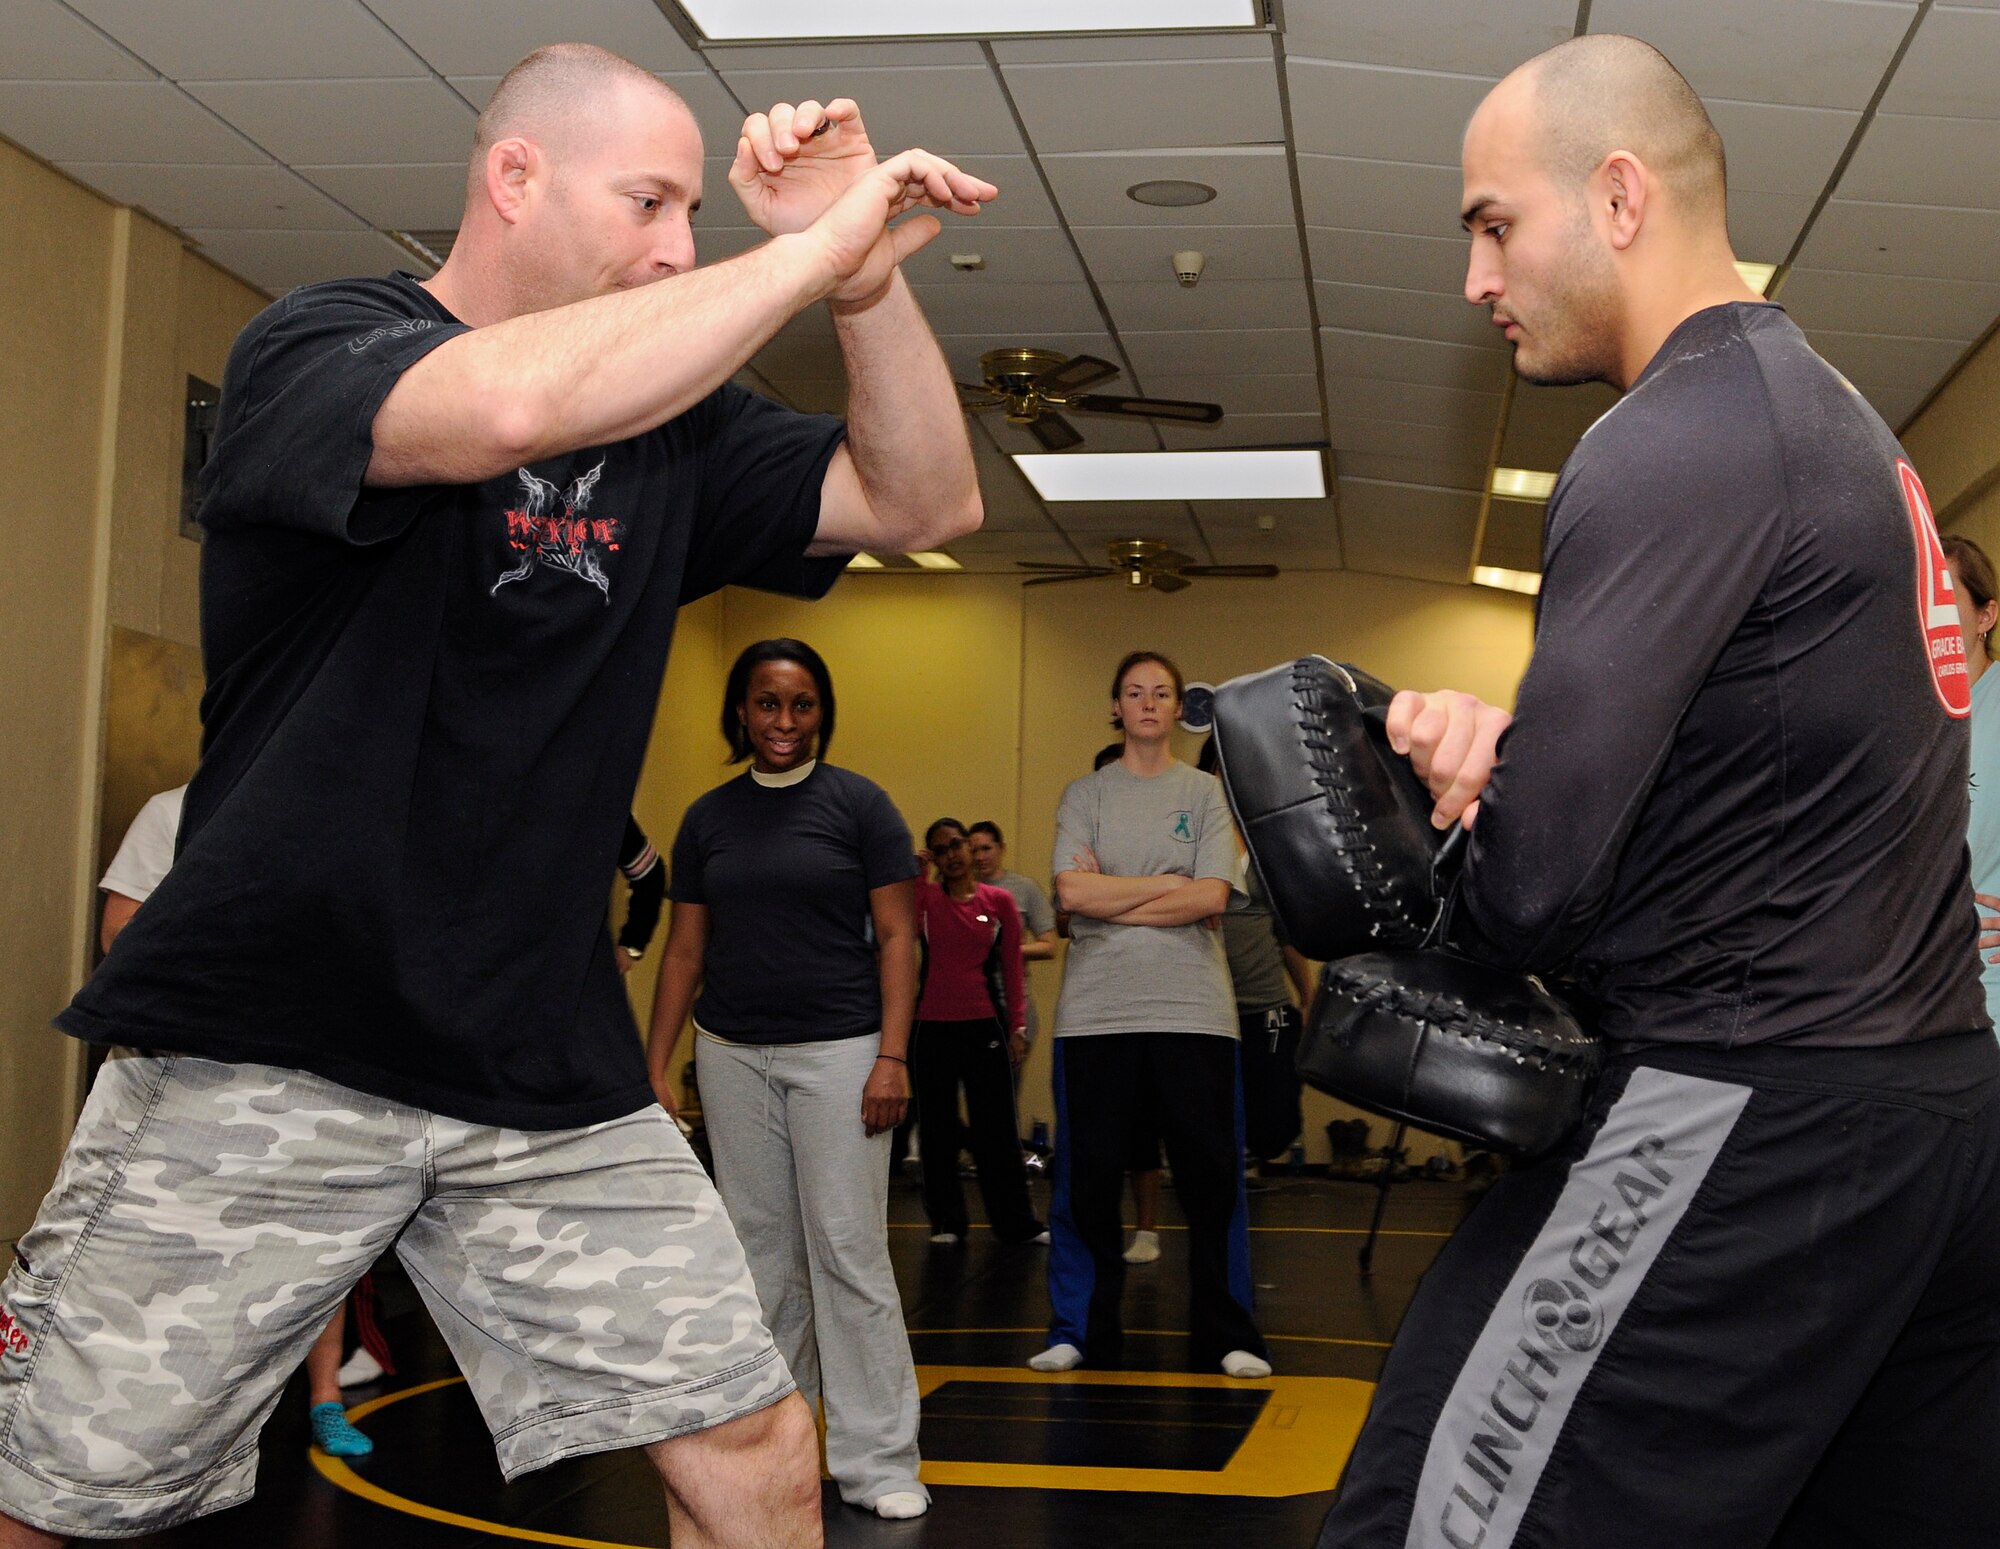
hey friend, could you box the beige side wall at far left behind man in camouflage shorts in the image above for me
[0,142,264,1243]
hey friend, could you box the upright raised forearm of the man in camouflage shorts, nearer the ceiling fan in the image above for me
[832,270,980,550]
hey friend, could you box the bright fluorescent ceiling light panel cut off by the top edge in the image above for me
[680,0,1258,42]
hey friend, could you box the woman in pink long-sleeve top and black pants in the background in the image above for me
[910,819,1048,1247]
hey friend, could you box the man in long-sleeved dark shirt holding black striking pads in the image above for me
[1320,36,2000,1549]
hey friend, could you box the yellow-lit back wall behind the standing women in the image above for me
[632,574,1532,1157]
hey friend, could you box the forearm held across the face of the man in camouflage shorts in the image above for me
[366,236,832,486]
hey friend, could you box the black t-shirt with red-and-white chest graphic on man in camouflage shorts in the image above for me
[58,274,842,1129]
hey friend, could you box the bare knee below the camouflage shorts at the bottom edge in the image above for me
[646,1393,826,1549]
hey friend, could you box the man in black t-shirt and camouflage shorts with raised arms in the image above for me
[0,44,994,1549]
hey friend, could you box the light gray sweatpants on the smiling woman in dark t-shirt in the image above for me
[694,1035,930,1507]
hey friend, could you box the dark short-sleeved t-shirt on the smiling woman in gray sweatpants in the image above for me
[668,760,916,1043]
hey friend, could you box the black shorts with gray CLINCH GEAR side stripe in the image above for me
[1320,1033,2000,1549]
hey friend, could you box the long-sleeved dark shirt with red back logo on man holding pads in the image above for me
[1458,302,1986,1047]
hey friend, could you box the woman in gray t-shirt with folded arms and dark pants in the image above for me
[1028,650,1270,1377]
